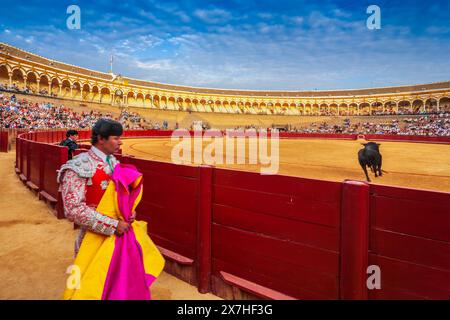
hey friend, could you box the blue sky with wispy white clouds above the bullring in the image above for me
[0,0,450,90]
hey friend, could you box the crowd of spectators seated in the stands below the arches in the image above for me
[0,92,450,136]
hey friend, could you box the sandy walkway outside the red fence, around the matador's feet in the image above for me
[0,152,219,300]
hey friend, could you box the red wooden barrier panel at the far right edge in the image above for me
[369,185,450,299]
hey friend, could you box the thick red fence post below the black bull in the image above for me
[340,180,369,300]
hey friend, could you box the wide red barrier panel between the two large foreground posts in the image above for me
[212,169,341,299]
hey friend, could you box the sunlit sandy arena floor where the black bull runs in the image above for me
[122,138,450,192]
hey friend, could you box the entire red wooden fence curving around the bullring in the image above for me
[16,131,450,299]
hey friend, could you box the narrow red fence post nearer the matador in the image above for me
[197,166,213,293]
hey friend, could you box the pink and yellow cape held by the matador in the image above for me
[63,163,165,300]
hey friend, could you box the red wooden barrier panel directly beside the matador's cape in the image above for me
[122,157,199,285]
